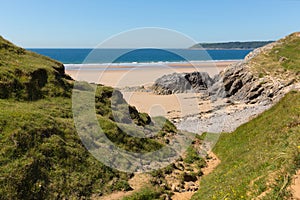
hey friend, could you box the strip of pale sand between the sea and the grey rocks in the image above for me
[66,61,234,88]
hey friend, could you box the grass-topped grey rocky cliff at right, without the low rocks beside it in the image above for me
[209,33,300,103]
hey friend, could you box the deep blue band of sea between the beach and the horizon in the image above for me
[28,49,251,64]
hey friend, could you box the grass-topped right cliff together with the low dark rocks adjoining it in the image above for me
[153,33,300,103]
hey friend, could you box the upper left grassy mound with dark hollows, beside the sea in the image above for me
[0,36,72,100]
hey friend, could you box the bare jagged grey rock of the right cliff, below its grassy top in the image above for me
[208,42,293,103]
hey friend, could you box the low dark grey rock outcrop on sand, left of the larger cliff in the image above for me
[152,72,213,95]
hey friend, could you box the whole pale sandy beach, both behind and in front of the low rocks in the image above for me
[66,61,234,120]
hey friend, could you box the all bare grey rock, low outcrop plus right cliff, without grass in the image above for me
[152,37,295,103]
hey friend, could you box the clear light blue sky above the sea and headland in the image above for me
[0,0,300,48]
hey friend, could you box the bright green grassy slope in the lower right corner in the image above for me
[193,92,300,200]
